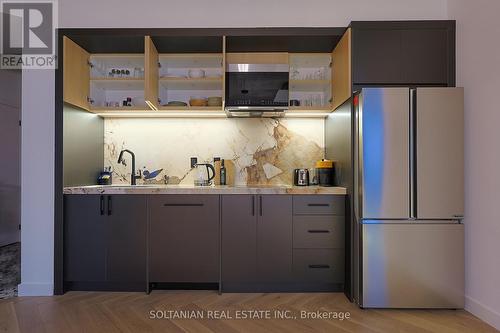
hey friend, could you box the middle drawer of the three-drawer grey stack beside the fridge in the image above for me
[293,215,345,249]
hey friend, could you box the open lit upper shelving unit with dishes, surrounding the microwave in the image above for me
[63,30,351,117]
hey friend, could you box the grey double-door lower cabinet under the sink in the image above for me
[64,194,147,290]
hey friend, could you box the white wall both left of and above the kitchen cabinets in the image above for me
[20,0,446,295]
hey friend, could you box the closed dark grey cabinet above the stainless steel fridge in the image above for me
[351,21,455,86]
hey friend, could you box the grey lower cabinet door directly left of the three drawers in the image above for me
[257,195,292,283]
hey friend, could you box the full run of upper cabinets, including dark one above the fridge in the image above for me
[62,21,455,117]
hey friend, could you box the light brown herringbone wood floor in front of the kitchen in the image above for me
[0,291,497,333]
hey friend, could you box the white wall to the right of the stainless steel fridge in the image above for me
[448,0,500,329]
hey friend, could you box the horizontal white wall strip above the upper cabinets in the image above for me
[59,0,446,28]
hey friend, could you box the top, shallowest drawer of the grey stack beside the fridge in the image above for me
[293,195,345,215]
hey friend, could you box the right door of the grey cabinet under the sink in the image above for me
[106,194,147,283]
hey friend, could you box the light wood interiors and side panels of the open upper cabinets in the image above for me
[64,34,351,117]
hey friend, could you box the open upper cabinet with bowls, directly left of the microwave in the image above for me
[146,36,224,112]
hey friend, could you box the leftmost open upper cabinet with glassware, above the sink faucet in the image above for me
[63,36,146,112]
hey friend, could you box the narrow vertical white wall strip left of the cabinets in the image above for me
[19,70,55,296]
